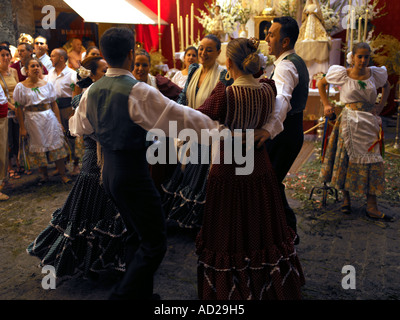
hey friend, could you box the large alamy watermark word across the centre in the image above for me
[146,121,254,175]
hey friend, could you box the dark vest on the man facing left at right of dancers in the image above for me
[284,53,310,115]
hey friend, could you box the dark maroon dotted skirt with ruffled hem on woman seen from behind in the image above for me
[196,150,305,300]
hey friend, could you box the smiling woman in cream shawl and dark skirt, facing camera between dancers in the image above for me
[162,34,228,228]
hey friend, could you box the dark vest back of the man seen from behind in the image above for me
[87,75,147,151]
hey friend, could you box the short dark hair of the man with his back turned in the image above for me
[100,27,136,67]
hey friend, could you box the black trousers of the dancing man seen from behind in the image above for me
[103,149,167,300]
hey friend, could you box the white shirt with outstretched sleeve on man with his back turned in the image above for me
[69,68,224,137]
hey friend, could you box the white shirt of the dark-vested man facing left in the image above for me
[263,49,299,139]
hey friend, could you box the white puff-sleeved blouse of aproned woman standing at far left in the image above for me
[14,82,57,106]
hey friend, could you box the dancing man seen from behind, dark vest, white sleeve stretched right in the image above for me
[69,28,225,299]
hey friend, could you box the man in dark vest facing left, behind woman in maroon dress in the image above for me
[255,17,309,244]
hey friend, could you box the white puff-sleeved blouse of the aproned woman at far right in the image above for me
[326,65,388,104]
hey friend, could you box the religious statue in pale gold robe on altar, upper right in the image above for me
[299,0,328,41]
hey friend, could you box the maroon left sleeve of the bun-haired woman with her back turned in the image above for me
[197,81,227,123]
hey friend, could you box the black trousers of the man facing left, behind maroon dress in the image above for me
[266,112,304,232]
